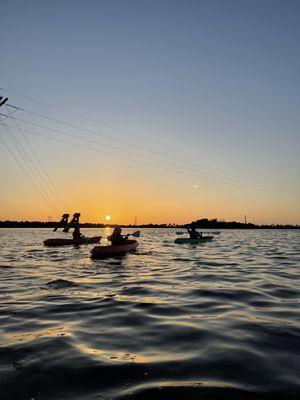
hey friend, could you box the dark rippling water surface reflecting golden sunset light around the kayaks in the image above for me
[0,229,300,400]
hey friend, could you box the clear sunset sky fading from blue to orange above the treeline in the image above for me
[0,0,300,224]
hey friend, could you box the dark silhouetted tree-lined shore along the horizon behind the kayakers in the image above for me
[0,218,300,229]
